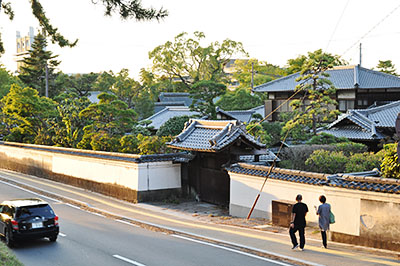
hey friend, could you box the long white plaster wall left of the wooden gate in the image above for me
[0,143,181,191]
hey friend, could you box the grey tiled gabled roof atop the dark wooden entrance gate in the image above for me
[168,119,265,152]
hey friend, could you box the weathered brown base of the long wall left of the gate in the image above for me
[0,153,181,203]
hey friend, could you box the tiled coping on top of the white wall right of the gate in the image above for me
[227,163,400,194]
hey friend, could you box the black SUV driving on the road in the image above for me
[0,199,59,247]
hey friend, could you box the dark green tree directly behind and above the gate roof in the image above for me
[190,80,226,119]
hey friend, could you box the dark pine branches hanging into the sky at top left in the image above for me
[0,0,168,55]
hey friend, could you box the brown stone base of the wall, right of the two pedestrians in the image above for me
[331,232,400,251]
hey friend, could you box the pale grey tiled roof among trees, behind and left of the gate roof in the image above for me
[145,106,200,129]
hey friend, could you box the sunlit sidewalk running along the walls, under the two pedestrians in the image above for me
[0,170,400,266]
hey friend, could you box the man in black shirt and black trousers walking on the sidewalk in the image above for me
[289,194,308,250]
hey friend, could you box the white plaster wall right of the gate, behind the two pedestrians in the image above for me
[229,172,400,236]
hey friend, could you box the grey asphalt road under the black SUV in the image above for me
[0,177,294,266]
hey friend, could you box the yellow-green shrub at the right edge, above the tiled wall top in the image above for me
[381,144,400,179]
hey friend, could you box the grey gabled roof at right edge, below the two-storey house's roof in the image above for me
[322,101,400,140]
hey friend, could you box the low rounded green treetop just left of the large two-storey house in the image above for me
[216,88,263,111]
